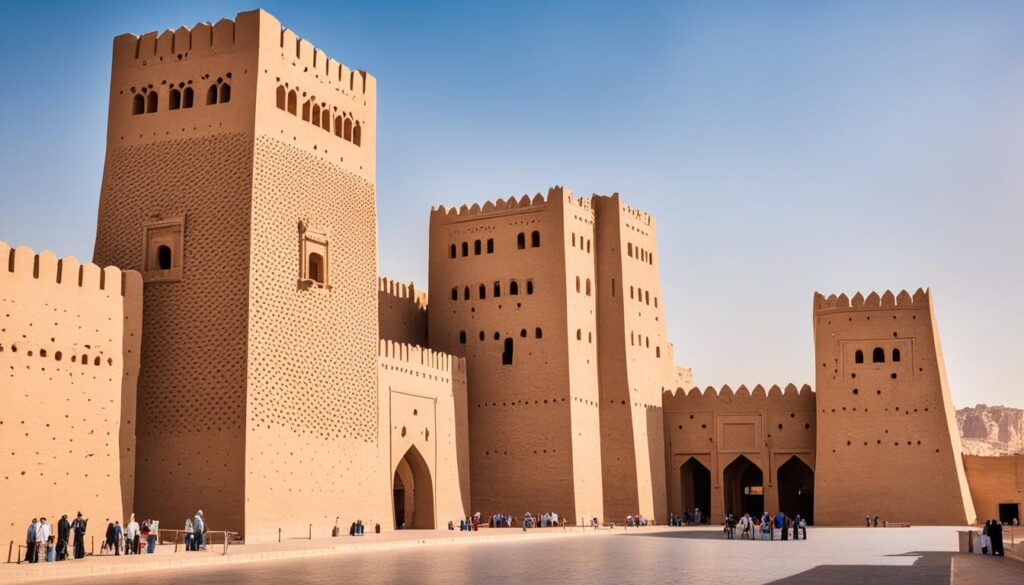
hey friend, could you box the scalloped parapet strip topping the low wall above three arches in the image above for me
[663,384,815,412]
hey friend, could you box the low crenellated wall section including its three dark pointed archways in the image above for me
[664,384,816,524]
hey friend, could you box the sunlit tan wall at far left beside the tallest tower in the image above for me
[0,242,142,543]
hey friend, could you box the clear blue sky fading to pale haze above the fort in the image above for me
[0,0,1024,407]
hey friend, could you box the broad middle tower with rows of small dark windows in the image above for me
[429,187,603,518]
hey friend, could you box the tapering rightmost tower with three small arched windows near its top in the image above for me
[814,289,975,526]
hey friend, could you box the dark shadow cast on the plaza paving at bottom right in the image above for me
[771,551,953,585]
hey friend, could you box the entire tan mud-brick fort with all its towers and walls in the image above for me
[0,10,1024,542]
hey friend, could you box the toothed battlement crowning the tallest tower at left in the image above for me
[114,9,375,94]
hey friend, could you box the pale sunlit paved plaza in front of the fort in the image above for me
[8,527,1024,585]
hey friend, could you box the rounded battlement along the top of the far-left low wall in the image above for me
[0,241,142,298]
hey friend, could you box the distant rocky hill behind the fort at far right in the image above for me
[956,405,1024,455]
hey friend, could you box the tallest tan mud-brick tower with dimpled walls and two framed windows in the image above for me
[94,10,391,542]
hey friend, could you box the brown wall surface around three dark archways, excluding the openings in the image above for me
[664,384,820,524]
